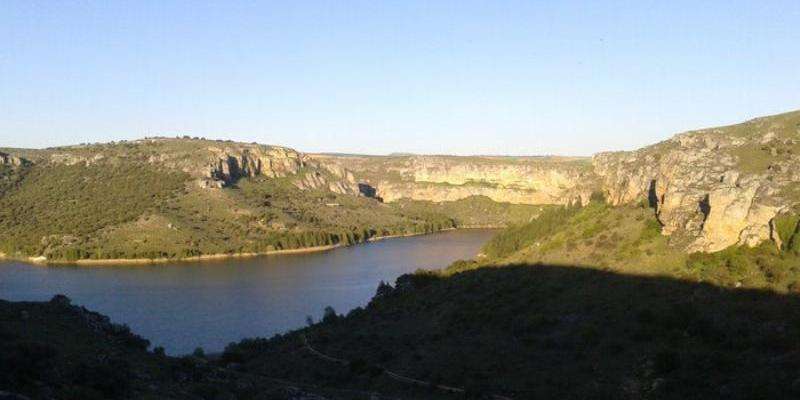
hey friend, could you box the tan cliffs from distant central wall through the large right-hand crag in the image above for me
[318,112,800,252]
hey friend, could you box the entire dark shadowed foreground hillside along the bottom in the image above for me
[0,265,800,400]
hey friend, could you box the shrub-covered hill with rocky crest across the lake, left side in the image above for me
[0,138,542,262]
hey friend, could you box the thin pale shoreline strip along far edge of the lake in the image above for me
[0,226,497,266]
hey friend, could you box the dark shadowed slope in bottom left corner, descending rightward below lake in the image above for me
[0,296,388,400]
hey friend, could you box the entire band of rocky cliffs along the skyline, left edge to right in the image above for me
[7,112,800,252]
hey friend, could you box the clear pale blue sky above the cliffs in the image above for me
[0,0,800,155]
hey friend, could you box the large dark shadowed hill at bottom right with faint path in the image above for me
[224,266,800,399]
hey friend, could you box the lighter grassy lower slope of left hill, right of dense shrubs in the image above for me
[83,174,454,258]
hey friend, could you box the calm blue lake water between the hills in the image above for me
[0,230,495,354]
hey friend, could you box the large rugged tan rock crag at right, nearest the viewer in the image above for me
[592,112,800,252]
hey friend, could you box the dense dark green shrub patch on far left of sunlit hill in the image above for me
[0,164,185,259]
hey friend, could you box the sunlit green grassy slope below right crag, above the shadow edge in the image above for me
[478,203,800,292]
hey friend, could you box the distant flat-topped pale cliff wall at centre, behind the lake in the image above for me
[316,156,596,204]
